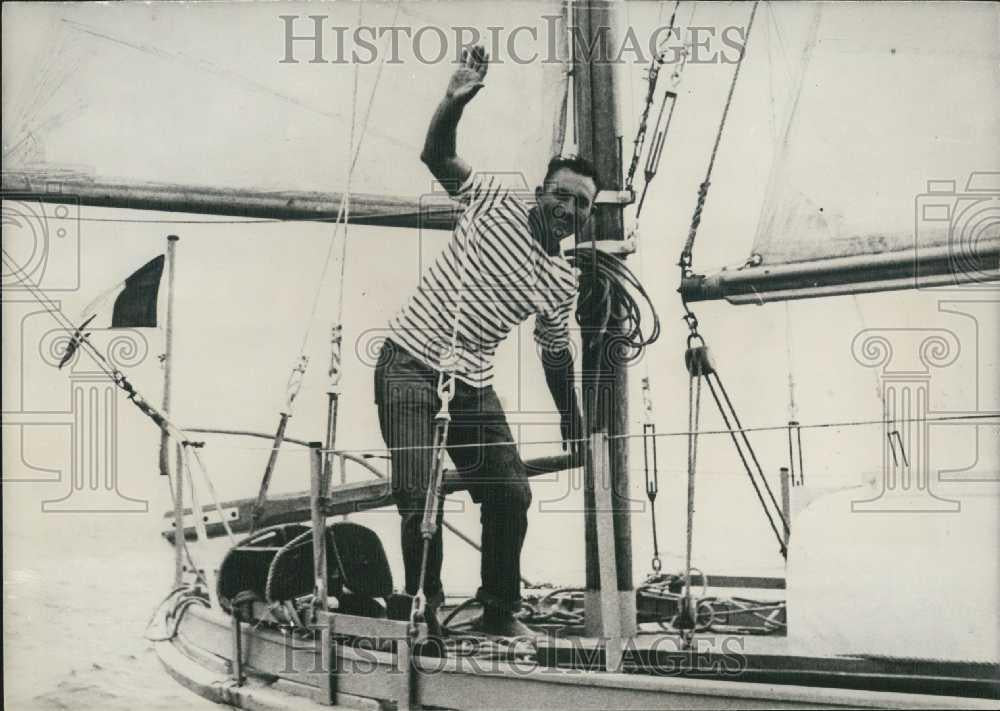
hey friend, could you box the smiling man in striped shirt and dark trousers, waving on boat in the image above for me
[375,47,597,636]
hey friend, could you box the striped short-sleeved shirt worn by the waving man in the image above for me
[389,174,577,388]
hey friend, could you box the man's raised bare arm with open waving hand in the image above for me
[420,45,489,195]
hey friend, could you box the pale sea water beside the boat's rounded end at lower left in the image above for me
[3,516,218,711]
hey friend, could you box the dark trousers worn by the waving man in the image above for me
[375,340,531,611]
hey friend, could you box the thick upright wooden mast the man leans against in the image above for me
[573,0,635,636]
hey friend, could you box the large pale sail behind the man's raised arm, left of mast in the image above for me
[3,0,567,203]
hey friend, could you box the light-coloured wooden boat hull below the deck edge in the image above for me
[157,607,996,711]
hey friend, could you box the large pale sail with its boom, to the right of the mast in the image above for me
[688,3,1000,302]
